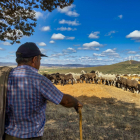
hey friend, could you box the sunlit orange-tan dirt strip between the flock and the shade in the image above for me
[56,83,140,107]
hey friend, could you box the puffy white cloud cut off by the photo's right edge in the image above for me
[126,30,140,41]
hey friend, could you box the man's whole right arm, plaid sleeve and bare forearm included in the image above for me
[40,76,83,112]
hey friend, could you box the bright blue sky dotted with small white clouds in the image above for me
[0,0,140,65]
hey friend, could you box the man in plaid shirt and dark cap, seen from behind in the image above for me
[5,42,83,140]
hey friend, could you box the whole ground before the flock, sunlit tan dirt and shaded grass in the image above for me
[43,83,140,140]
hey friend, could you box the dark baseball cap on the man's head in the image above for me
[16,42,48,58]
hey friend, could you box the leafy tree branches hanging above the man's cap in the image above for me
[0,0,74,44]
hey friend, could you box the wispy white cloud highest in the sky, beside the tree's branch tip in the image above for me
[57,4,79,17]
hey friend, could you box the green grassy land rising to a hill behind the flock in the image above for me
[39,61,140,74]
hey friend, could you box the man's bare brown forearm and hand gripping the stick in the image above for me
[60,94,83,113]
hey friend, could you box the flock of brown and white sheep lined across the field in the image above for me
[43,70,140,93]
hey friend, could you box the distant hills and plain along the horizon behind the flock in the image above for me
[0,60,140,74]
